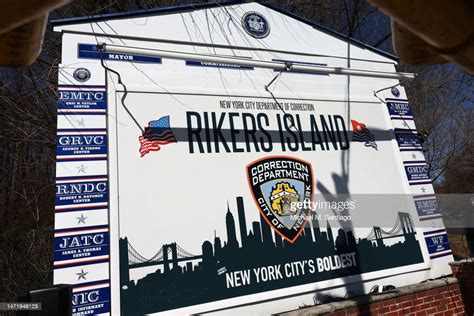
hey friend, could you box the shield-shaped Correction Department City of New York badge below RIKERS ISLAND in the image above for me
[247,156,314,243]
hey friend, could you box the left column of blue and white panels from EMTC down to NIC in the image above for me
[54,85,110,316]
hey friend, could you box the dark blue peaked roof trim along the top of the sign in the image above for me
[49,0,398,61]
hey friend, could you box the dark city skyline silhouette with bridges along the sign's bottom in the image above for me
[119,197,423,315]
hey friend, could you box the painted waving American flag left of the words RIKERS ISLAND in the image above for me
[138,115,177,157]
